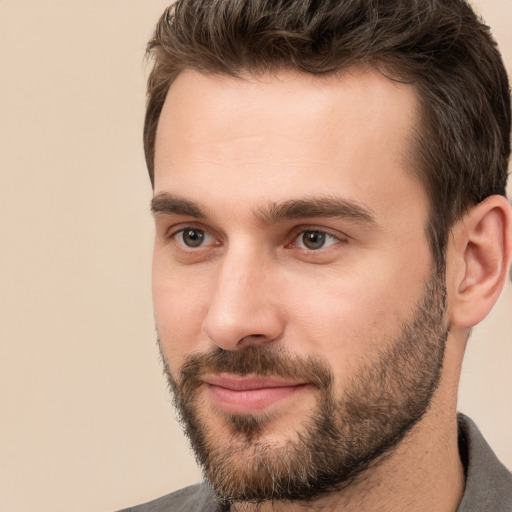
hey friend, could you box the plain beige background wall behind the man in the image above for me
[0,0,512,512]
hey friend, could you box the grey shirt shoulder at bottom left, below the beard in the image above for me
[119,483,222,512]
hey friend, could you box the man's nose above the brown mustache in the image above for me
[203,249,285,350]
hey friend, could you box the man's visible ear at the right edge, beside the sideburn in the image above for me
[446,192,512,328]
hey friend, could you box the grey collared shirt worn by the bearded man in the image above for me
[120,414,512,512]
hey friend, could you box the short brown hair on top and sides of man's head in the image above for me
[144,0,510,263]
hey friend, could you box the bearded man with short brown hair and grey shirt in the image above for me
[122,0,512,512]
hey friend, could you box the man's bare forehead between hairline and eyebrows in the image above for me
[155,69,422,222]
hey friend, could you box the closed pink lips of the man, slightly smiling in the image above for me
[202,375,307,414]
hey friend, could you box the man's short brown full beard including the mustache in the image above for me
[164,272,447,504]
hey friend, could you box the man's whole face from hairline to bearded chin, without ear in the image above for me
[153,70,446,501]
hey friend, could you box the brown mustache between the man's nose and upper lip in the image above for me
[162,345,333,392]
